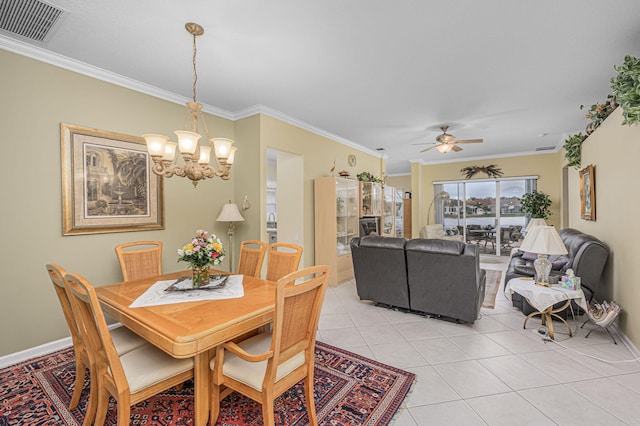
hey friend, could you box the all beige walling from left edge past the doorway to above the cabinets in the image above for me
[0,50,384,356]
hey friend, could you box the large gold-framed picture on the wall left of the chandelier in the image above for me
[60,123,164,235]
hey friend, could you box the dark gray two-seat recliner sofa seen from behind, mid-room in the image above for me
[351,236,485,323]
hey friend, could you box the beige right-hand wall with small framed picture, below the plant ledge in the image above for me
[569,108,640,347]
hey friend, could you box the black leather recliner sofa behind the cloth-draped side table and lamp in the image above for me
[505,228,609,315]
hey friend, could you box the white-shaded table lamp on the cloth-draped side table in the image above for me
[520,226,567,287]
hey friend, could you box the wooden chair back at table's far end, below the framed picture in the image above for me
[116,241,162,281]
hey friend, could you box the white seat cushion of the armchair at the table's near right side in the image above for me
[209,333,304,392]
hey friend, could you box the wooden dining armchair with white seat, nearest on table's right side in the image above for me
[209,265,329,425]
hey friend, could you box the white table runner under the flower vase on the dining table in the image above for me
[129,275,244,308]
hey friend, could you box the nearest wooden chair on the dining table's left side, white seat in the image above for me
[64,274,193,426]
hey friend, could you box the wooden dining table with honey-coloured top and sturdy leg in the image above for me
[96,270,275,426]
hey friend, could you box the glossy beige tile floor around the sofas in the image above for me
[318,259,640,426]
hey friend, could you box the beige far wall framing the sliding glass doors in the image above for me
[412,153,563,237]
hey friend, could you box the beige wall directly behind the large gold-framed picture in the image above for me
[0,50,238,355]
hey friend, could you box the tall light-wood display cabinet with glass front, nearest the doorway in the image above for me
[314,177,360,286]
